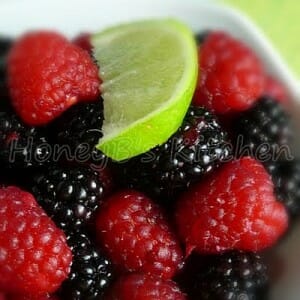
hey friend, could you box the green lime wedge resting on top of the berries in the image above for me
[92,19,198,161]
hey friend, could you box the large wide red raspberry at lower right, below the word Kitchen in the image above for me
[176,157,288,253]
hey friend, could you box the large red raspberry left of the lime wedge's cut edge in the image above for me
[8,31,100,125]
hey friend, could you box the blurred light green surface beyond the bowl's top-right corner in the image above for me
[219,0,300,77]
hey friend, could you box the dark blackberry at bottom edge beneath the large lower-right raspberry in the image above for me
[192,252,268,300]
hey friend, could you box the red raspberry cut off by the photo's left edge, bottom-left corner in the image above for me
[0,187,72,295]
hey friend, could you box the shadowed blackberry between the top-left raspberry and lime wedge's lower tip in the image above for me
[51,98,106,164]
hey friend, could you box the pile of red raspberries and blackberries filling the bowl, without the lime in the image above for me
[0,19,300,300]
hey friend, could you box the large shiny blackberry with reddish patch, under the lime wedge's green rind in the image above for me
[115,107,231,200]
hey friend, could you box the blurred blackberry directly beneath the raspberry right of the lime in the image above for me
[233,97,292,160]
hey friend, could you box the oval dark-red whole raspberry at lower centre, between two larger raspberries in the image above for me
[96,190,182,279]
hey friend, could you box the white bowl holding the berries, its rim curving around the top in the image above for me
[0,0,300,300]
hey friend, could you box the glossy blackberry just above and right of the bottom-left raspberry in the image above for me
[32,166,104,229]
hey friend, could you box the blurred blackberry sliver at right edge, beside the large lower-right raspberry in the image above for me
[265,160,300,217]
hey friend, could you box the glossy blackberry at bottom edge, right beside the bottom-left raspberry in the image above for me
[58,232,113,300]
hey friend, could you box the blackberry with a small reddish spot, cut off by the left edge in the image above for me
[0,108,51,168]
